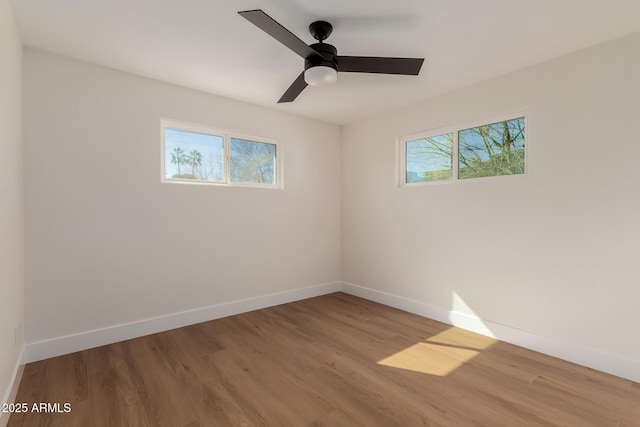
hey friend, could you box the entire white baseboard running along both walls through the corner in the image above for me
[21,282,640,384]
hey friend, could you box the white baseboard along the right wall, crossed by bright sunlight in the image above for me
[342,282,640,382]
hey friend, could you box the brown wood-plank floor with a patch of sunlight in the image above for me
[9,293,640,427]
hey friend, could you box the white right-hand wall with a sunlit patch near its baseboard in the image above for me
[342,34,640,377]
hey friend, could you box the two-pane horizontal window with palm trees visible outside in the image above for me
[161,120,281,188]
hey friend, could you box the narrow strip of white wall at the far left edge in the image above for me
[0,0,24,414]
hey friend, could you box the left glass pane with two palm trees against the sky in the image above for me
[164,128,224,182]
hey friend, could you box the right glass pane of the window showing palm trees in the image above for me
[229,138,276,184]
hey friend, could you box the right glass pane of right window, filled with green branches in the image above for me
[458,117,525,179]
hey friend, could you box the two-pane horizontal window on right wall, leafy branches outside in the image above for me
[400,116,525,185]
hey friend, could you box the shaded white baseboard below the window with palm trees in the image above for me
[25,282,341,363]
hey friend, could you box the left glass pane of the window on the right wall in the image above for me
[406,133,453,184]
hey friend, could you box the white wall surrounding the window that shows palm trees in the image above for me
[25,50,341,343]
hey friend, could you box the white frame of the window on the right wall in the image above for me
[396,111,531,187]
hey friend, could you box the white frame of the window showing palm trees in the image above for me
[160,119,283,189]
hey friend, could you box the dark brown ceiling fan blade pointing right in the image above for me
[337,56,424,76]
